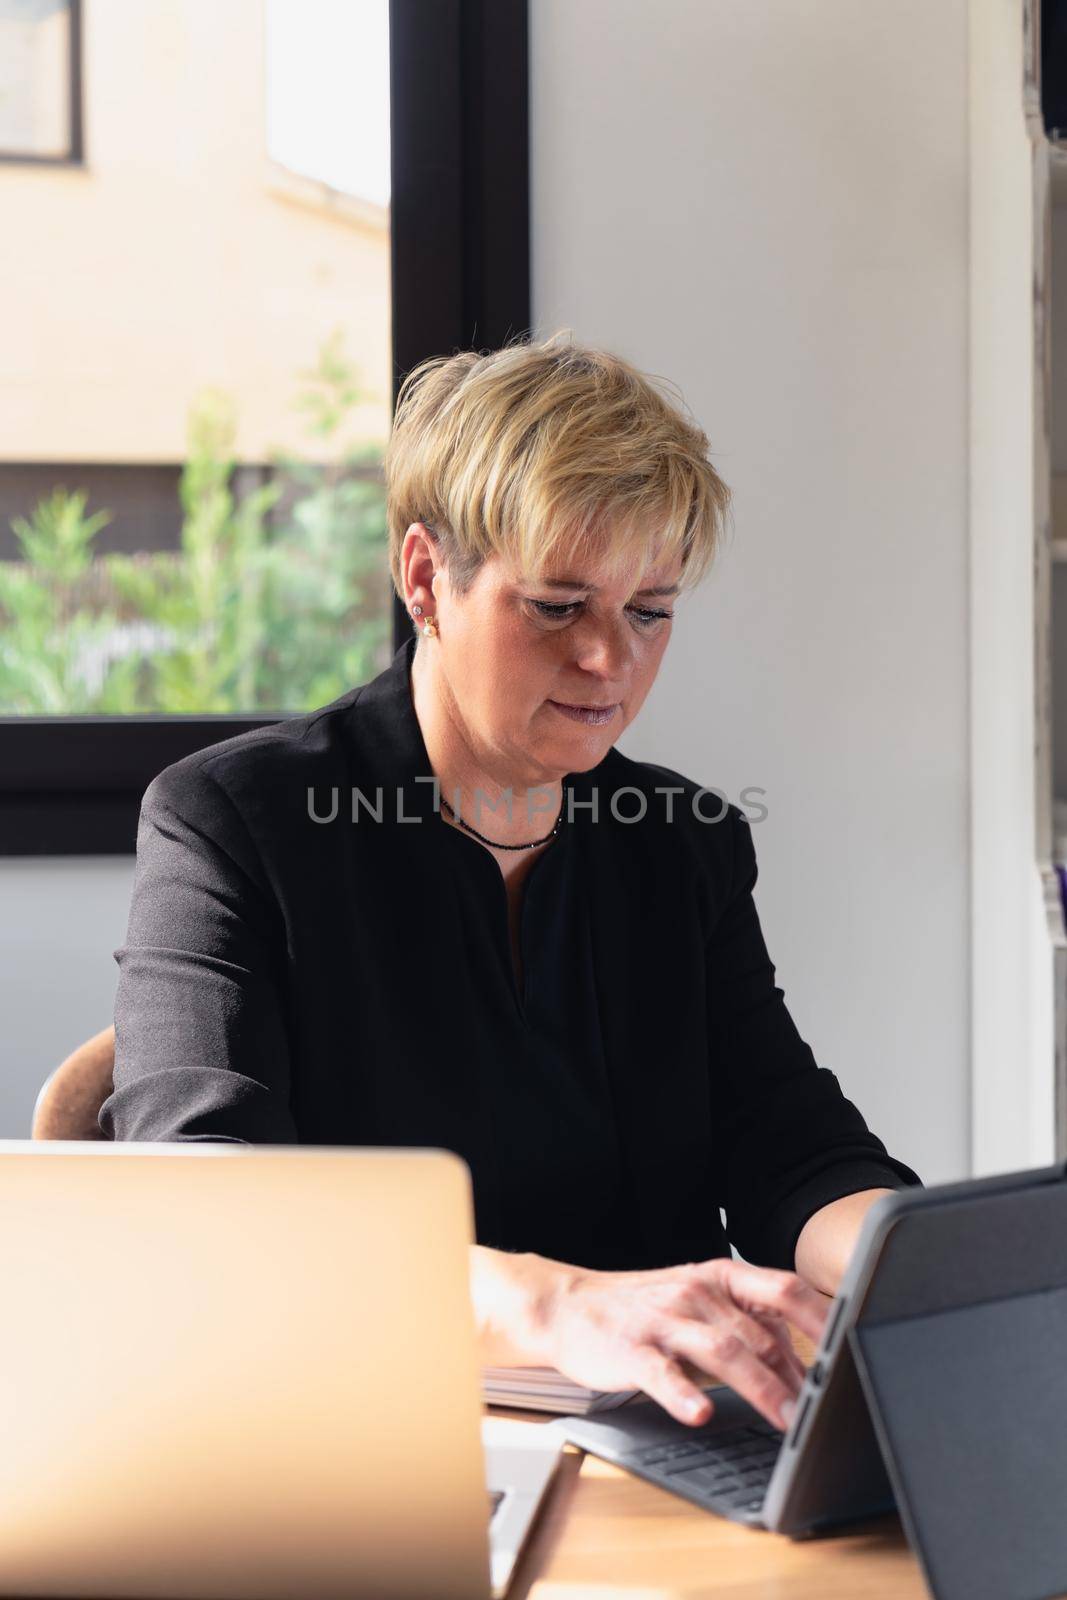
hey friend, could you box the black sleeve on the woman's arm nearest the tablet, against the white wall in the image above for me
[707,806,921,1272]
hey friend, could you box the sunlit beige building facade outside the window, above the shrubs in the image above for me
[0,0,392,470]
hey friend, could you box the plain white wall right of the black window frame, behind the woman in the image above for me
[531,0,969,1181]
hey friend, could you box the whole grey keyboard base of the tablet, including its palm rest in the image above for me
[560,1394,782,1522]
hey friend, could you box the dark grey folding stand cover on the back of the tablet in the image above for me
[849,1182,1067,1600]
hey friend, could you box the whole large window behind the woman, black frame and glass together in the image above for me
[0,0,530,854]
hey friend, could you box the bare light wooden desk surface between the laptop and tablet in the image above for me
[507,1341,926,1600]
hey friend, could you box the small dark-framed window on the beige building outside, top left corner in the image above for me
[0,0,82,162]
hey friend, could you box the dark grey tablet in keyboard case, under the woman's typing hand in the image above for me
[553,1165,1067,1600]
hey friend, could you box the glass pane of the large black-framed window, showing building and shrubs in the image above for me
[0,0,392,717]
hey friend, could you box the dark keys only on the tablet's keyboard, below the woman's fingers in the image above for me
[619,1422,782,1512]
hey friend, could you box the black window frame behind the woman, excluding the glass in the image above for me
[0,0,530,856]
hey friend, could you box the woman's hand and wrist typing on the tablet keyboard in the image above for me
[475,1251,829,1429]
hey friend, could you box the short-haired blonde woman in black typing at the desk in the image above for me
[101,334,920,1426]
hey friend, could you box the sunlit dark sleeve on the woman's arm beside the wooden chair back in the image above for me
[99,762,296,1144]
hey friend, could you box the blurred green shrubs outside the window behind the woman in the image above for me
[0,331,392,714]
